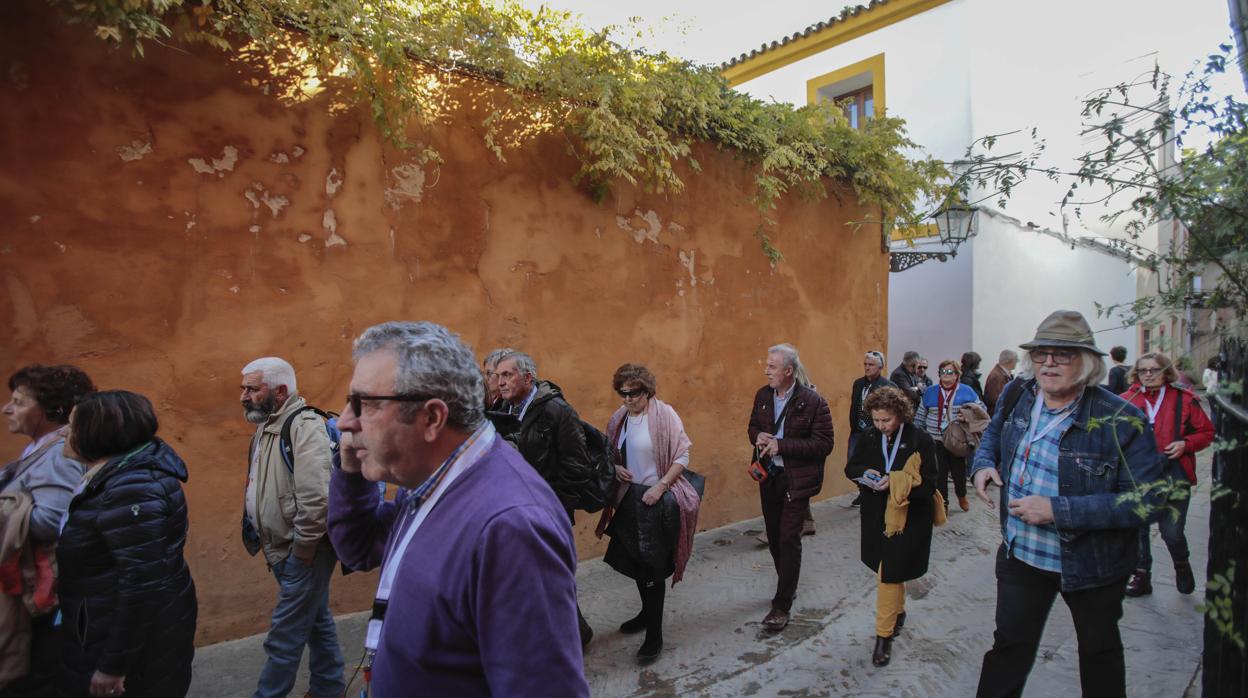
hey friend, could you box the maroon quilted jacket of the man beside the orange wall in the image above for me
[749,386,834,499]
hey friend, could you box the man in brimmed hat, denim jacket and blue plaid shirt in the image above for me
[972,310,1163,698]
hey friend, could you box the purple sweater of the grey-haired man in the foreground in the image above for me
[329,438,589,698]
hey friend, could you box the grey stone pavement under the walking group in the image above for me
[191,452,1209,698]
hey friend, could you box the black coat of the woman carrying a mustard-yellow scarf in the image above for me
[845,425,936,584]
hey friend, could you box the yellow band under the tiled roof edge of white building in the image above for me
[721,0,950,87]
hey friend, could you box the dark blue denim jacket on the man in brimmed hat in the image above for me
[971,380,1164,592]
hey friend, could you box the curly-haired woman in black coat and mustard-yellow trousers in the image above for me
[845,387,943,667]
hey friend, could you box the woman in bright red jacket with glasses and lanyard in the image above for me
[1122,353,1213,597]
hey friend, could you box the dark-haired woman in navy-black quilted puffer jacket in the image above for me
[56,391,197,698]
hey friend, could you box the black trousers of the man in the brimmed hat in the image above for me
[976,546,1127,698]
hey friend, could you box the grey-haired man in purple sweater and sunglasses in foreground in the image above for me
[328,322,589,698]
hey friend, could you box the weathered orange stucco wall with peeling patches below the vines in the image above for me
[0,2,887,642]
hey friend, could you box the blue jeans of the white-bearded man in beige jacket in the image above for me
[252,546,347,698]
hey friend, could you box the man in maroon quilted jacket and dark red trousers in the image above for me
[749,345,832,631]
